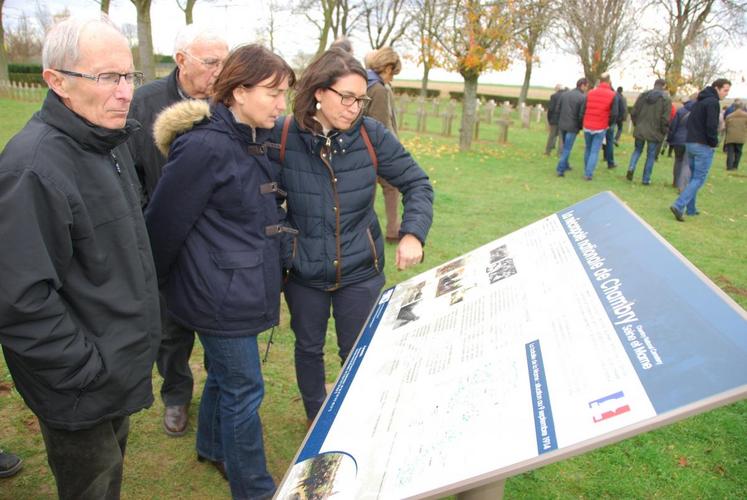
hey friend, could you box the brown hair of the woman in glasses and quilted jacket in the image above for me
[293,48,367,131]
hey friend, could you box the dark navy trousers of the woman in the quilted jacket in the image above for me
[284,274,385,420]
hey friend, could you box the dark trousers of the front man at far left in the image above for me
[39,417,130,500]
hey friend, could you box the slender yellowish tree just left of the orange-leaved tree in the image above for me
[405,0,448,97]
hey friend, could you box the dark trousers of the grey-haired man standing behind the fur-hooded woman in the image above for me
[156,295,195,406]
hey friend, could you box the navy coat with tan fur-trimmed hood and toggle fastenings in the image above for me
[145,100,284,337]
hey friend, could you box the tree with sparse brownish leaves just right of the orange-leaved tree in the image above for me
[516,0,556,104]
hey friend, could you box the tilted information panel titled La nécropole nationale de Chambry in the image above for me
[277,193,747,499]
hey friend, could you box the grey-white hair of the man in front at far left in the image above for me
[42,14,124,69]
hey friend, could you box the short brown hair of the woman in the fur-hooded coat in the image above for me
[213,43,296,106]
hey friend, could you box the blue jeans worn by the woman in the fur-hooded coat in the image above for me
[197,333,275,499]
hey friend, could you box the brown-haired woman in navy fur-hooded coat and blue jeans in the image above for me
[145,45,295,498]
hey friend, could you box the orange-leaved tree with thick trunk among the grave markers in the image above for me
[436,0,516,151]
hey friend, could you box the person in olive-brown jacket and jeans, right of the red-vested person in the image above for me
[625,79,672,186]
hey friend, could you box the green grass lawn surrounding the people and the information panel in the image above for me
[0,96,747,499]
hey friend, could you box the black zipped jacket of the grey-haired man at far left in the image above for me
[0,91,161,430]
